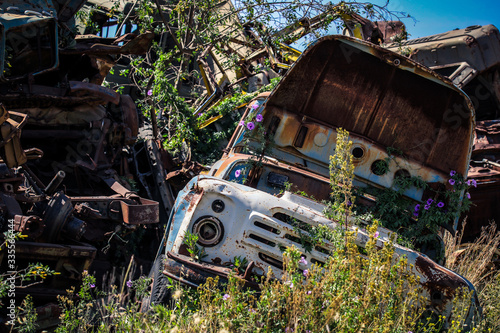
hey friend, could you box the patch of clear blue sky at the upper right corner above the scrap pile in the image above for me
[372,0,500,39]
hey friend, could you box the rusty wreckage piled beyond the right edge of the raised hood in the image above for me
[386,24,500,242]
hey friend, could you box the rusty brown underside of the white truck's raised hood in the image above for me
[265,35,474,175]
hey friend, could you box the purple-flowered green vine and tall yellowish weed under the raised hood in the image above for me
[325,129,476,253]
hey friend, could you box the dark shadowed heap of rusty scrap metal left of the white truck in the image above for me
[0,0,173,302]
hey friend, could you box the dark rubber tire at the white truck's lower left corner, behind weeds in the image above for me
[141,254,171,312]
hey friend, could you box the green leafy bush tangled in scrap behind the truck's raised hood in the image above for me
[95,0,407,164]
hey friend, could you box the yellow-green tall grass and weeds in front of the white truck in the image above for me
[17,225,460,333]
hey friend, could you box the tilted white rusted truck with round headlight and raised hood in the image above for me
[151,36,478,323]
